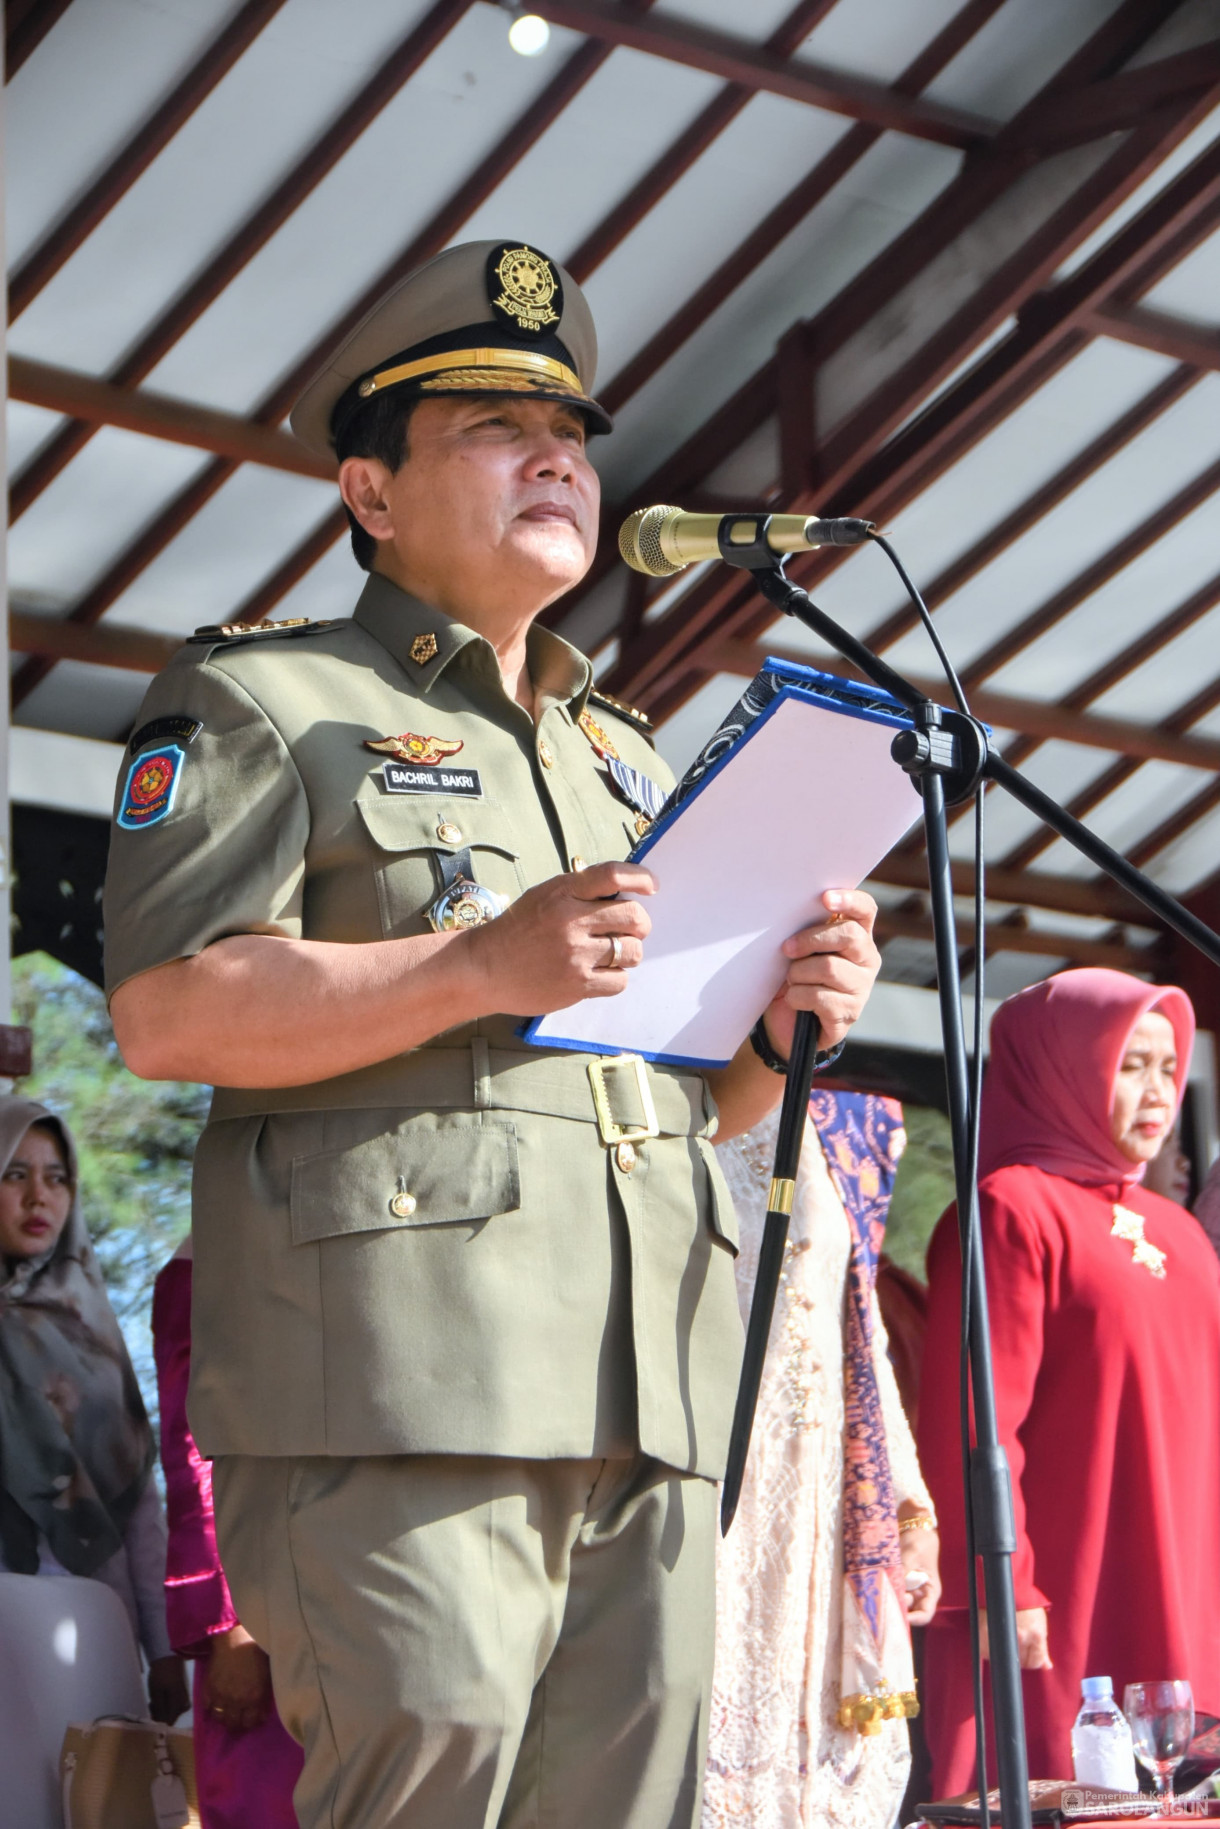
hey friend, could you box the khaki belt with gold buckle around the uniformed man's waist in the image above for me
[210,1037,715,1147]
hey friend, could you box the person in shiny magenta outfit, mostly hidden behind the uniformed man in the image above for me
[152,1240,302,1829]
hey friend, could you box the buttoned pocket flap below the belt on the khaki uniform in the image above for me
[291,1116,521,1246]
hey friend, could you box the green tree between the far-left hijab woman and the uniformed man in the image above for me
[13,953,209,1417]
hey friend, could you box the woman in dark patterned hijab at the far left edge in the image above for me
[0,1097,188,1721]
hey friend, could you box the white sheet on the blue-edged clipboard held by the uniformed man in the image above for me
[529,693,922,1066]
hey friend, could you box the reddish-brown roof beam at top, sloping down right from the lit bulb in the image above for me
[530,0,995,148]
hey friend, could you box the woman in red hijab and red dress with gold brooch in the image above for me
[918,969,1220,1798]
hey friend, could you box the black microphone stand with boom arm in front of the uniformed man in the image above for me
[719,514,1220,1829]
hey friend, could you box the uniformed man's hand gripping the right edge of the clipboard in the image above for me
[766,889,882,1059]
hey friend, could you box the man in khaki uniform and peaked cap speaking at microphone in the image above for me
[106,243,876,1829]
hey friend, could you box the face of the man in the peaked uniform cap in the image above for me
[340,395,600,618]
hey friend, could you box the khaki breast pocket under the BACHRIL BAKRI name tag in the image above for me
[357,794,525,940]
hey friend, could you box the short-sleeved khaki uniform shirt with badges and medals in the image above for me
[106,576,741,1476]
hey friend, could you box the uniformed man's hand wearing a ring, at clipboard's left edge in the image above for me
[463,863,657,1017]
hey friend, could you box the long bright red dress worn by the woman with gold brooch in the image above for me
[918,1165,1220,1798]
